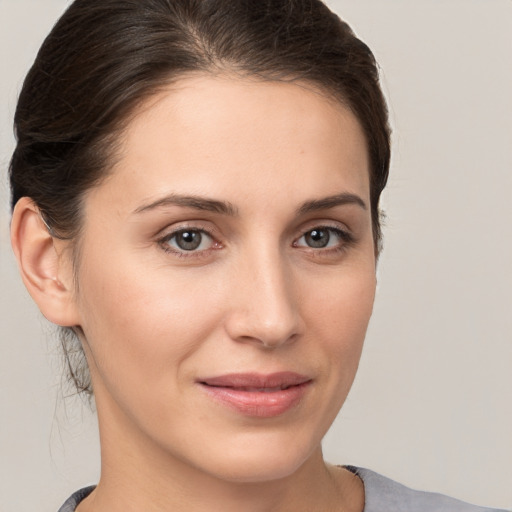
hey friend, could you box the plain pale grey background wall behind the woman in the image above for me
[0,0,512,512]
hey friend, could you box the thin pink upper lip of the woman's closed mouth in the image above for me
[198,372,311,389]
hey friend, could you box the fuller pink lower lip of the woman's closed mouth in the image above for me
[201,381,311,418]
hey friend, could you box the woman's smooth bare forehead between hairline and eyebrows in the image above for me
[94,75,369,212]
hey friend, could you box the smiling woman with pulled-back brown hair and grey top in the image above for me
[6,0,510,512]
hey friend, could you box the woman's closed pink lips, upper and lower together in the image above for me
[198,372,311,418]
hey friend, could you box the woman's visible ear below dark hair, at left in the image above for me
[11,197,80,327]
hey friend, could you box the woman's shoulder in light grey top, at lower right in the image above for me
[347,467,506,512]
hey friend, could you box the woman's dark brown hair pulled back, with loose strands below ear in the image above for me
[10,0,390,392]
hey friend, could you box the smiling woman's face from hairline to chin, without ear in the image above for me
[72,76,375,481]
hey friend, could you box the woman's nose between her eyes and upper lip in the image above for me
[225,245,302,349]
